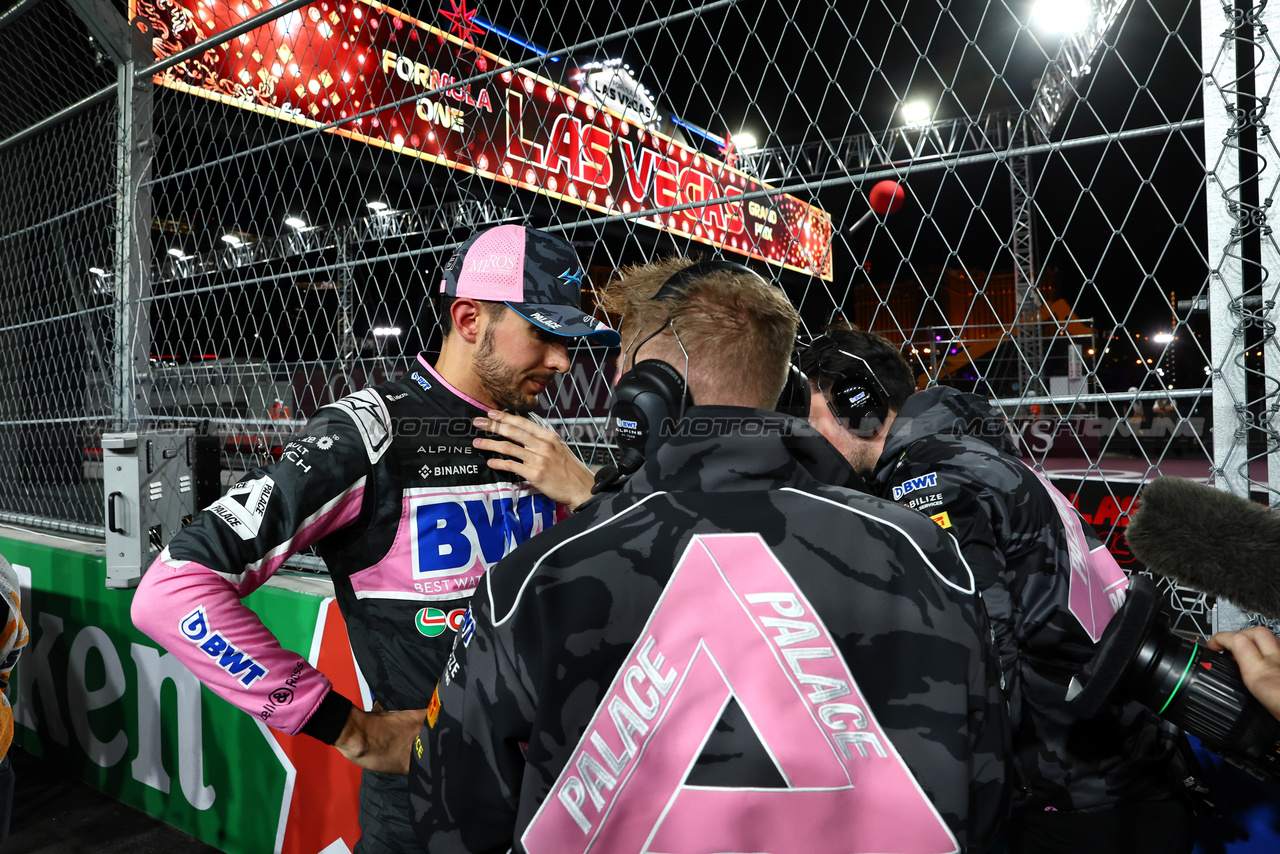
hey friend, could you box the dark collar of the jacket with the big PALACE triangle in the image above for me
[622,406,869,494]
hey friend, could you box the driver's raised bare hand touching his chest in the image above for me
[472,410,595,507]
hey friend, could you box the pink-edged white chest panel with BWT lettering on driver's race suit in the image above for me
[408,484,556,598]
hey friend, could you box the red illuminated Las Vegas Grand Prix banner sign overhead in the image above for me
[129,0,832,280]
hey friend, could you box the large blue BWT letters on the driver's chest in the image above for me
[412,494,556,579]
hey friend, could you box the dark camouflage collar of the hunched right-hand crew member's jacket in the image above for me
[873,385,1018,485]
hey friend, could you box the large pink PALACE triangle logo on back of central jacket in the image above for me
[521,534,959,854]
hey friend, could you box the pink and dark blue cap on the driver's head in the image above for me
[440,225,621,347]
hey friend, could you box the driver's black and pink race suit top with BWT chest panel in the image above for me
[133,356,557,741]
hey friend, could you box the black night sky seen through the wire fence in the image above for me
[0,0,1210,396]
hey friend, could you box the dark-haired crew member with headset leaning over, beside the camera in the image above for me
[800,328,1193,854]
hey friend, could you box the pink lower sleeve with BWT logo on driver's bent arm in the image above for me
[132,549,333,735]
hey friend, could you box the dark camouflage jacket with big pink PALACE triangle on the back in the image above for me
[410,406,1007,854]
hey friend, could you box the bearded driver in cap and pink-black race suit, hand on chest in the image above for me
[133,225,618,854]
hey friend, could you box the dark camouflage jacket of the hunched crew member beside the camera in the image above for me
[873,388,1178,812]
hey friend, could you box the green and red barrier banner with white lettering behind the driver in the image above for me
[8,538,367,854]
